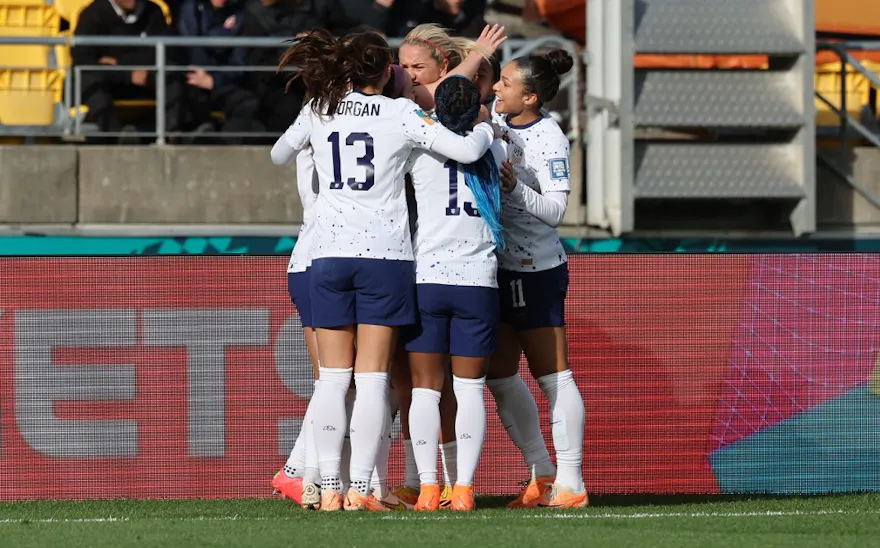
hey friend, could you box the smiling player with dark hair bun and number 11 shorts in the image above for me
[488,50,587,508]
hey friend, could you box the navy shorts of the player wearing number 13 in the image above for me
[309,258,417,328]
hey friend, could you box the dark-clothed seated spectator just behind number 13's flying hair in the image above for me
[242,0,352,133]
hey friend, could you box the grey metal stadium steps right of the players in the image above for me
[621,0,815,234]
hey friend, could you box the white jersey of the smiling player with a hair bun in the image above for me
[499,117,571,272]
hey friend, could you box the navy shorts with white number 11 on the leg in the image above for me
[498,263,568,331]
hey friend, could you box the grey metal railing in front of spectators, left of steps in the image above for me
[0,36,581,144]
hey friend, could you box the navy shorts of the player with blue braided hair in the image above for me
[404,284,500,358]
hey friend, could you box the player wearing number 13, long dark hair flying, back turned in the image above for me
[272,30,493,511]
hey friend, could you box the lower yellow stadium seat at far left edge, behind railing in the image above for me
[0,69,64,126]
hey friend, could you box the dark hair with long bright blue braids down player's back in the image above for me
[434,75,507,251]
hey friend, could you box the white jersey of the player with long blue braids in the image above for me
[406,141,505,287]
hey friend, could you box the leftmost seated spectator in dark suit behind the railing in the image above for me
[72,0,182,139]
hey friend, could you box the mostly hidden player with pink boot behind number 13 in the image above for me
[272,65,413,509]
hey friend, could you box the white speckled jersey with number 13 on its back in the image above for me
[284,91,490,260]
